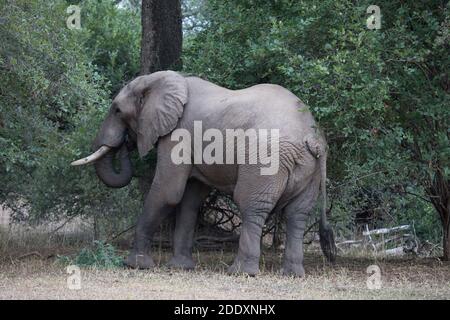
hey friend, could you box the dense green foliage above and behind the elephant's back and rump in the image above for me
[184,0,450,239]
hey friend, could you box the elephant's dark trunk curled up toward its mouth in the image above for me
[94,144,132,188]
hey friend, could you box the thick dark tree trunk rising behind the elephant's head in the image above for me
[141,0,183,74]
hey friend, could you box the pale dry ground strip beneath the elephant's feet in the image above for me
[0,251,450,300]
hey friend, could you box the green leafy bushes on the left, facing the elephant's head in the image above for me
[0,0,141,229]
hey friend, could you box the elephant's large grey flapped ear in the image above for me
[135,71,188,157]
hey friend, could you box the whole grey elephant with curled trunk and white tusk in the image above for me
[72,70,336,276]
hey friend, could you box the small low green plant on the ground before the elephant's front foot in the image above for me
[58,241,123,269]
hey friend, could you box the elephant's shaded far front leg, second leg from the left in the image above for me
[168,179,210,270]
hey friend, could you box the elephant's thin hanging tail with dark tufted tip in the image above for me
[305,135,337,262]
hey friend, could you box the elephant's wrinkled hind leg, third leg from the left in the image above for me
[228,169,287,275]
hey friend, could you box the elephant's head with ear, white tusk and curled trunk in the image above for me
[72,71,188,188]
